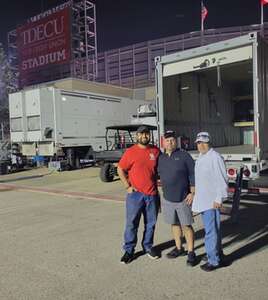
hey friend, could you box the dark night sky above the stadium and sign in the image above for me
[0,0,268,51]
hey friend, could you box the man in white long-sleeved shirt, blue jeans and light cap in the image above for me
[192,132,228,272]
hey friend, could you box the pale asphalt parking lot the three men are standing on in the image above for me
[0,168,268,300]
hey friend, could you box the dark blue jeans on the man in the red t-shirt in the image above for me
[123,192,159,253]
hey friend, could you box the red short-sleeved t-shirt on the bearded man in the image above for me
[119,145,160,195]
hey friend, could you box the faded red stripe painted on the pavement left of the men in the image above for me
[0,183,125,202]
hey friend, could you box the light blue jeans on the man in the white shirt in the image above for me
[201,209,222,266]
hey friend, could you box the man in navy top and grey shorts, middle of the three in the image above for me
[158,130,196,266]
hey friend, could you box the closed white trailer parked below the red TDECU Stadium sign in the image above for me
[9,84,148,167]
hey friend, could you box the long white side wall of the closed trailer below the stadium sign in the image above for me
[55,90,144,150]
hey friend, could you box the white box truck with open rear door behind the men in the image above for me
[155,32,268,179]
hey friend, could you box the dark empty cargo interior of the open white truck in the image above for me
[163,60,254,153]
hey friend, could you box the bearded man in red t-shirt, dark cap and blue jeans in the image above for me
[118,125,160,264]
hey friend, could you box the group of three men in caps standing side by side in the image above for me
[118,126,228,272]
